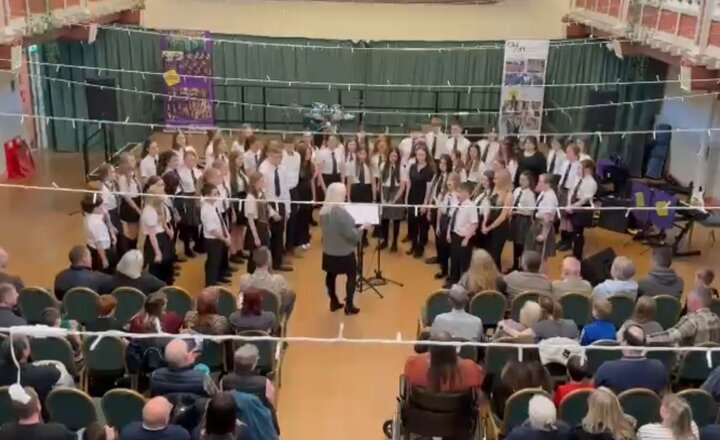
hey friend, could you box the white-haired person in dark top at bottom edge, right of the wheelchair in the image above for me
[505,394,568,440]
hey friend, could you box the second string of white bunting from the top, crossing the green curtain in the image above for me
[7,59,720,93]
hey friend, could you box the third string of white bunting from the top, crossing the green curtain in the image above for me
[11,70,720,119]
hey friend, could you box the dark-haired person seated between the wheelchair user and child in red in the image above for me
[492,350,553,417]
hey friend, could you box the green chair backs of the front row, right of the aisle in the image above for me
[418,290,682,330]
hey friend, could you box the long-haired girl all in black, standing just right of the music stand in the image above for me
[405,142,435,258]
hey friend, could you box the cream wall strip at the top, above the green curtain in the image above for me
[143,0,570,41]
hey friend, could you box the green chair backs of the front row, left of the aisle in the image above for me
[18,286,287,334]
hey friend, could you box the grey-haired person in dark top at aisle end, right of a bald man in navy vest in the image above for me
[220,344,275,408]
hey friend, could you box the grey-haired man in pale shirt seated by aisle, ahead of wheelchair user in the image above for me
[431,284,484,341]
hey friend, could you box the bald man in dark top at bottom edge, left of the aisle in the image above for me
[120,397,190,440]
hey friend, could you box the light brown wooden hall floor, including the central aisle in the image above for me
[0,154,720,440]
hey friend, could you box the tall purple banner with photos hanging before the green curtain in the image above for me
[160,31,215,127]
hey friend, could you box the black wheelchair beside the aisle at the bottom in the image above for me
[383,376,481,440]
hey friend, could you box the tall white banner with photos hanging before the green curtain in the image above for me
[499,40,550,135]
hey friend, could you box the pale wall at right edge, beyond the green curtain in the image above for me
[658,66,720,198]
